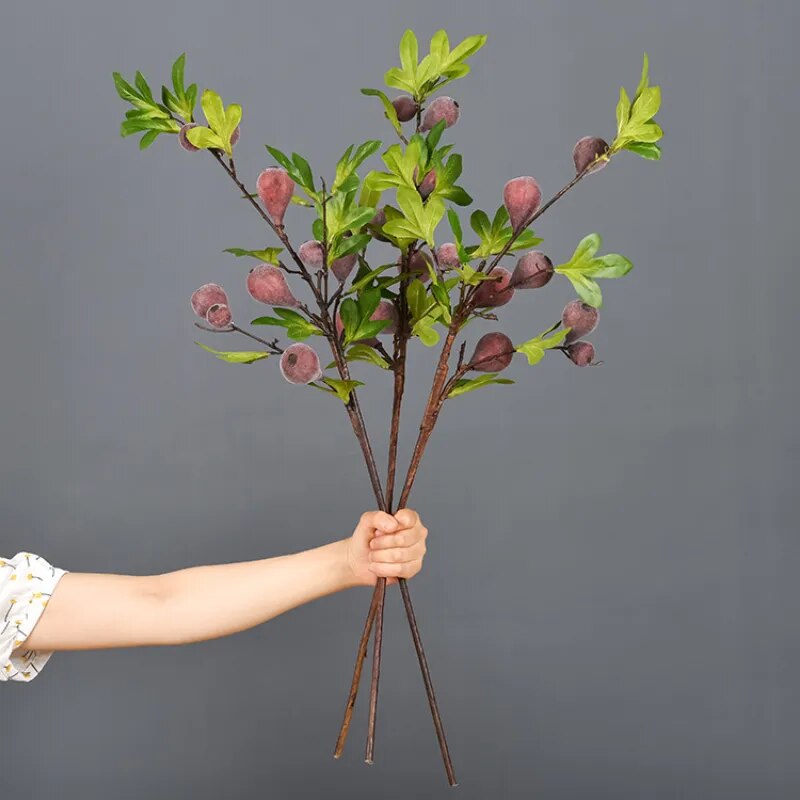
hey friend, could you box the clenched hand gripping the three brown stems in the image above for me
[347,508,428,586]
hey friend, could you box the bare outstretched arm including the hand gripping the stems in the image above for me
[23,510,427,651]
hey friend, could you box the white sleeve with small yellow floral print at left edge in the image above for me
[0,553,66,682]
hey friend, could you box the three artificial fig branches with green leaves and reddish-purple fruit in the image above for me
[114,30,662,785]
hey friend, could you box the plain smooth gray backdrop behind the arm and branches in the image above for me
[0,0,800,800]
